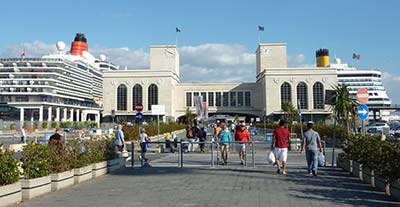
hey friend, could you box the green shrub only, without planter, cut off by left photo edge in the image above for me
[0,144,19,186]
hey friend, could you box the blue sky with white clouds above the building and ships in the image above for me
[0,0,400,104]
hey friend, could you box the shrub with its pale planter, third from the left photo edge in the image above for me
[48,142,74,191]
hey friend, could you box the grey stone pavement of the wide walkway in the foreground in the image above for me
[13,152,400,207]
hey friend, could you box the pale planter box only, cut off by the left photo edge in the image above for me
[0,181,22,207]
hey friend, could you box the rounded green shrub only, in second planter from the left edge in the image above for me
[22,143,50,179]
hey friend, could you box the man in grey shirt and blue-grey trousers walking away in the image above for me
[301,121,322,176]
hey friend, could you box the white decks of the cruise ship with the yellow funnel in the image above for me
[330,58,391,107]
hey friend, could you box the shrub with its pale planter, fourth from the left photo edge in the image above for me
[67,140,93,184]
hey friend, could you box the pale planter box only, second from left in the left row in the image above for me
[21,175,51,201]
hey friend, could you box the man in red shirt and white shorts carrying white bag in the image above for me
[271,120,290,175]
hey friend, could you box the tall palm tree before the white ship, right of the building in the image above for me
[333,85,357,133]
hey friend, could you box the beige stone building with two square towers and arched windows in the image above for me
[103,43,337,121]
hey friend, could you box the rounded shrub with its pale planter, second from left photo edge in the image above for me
[21,143,51,201]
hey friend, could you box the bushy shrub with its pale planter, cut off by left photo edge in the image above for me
[0,144,22,206]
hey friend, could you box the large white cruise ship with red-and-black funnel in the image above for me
[0,33,118,124]
